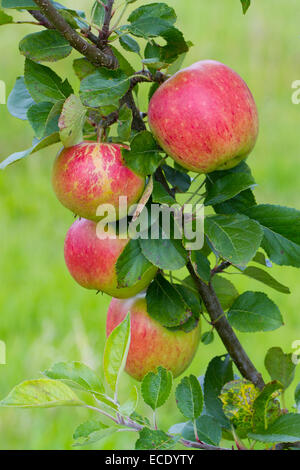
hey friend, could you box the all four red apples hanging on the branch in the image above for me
[52,61,258,380]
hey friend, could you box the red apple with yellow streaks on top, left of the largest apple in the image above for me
[52,141,145,220]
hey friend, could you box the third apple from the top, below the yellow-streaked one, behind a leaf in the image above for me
[64,219,157,299]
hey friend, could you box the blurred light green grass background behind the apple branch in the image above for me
[0,0,300,449]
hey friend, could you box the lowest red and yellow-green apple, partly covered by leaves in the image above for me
[106,294,201,381]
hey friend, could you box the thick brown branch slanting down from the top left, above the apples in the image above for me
[34,0,119,69]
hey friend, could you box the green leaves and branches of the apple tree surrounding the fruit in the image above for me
[0,0,300,449]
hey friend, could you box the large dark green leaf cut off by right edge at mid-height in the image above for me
[247,204,300,268]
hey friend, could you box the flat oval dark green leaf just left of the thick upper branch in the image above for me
[19,29,72,62]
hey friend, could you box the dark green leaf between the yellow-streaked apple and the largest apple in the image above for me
[122,131,161,176]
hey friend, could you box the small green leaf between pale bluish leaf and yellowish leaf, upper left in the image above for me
[27,101,61,139]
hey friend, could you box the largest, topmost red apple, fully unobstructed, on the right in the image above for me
[148,60,258,173]
